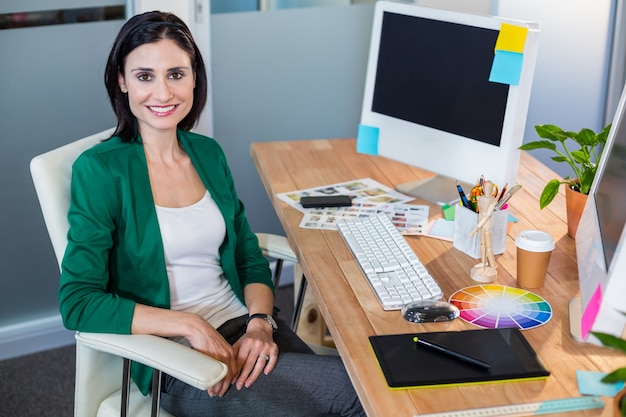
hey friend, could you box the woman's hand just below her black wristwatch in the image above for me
[233,319,278,390]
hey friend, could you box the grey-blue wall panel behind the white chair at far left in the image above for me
[0,0,124,359]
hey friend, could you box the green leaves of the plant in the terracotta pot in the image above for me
[519,124,611,209]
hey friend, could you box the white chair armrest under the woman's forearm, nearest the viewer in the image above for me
[76,332,228,390]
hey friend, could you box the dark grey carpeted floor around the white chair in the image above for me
[0,285,293,417]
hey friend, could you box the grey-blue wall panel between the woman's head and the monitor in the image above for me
[211,4,374,233]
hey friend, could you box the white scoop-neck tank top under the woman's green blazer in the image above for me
[156,191,248,334]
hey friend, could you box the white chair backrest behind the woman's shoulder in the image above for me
[30,128,115,267]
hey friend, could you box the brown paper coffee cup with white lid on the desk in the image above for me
[515,230,555,288]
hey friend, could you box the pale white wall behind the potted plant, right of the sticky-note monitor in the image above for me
[497,0,619,175]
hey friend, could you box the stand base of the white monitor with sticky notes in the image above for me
[396,175,474,206]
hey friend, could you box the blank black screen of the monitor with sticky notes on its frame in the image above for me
[372,12,509,146]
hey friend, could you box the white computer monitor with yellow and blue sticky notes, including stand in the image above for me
[359,1,539,204]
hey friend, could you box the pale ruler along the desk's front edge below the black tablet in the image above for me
[415,396,604,417]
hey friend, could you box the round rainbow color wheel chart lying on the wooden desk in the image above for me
[449,284,552,330]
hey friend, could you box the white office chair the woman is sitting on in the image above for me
[30,129,297,417]
